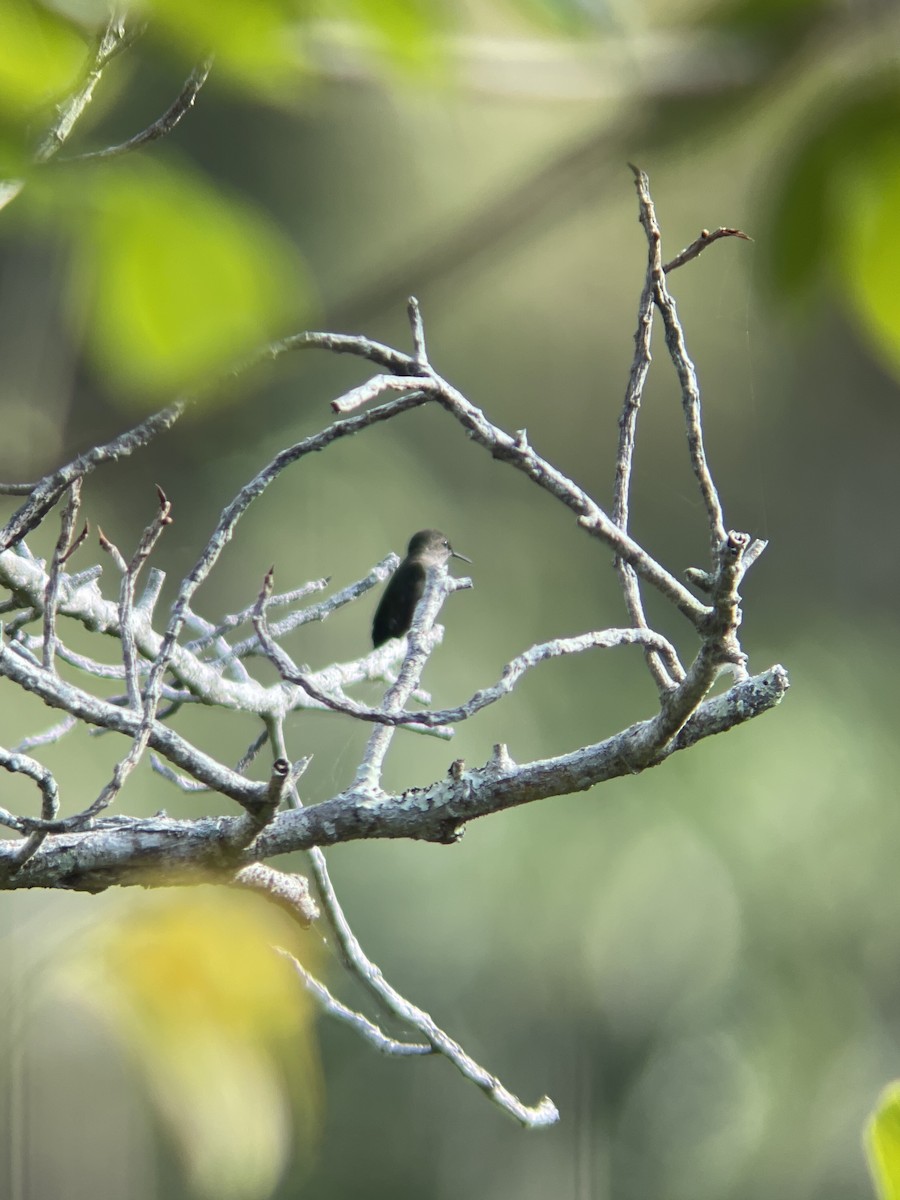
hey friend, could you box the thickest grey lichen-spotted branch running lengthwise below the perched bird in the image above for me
[0,666,790,892]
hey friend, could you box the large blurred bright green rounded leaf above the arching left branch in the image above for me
[68,158,308,401]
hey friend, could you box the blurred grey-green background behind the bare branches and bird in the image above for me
[0,0,900,1200]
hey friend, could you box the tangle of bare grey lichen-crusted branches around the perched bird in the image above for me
[0,25,788,1127]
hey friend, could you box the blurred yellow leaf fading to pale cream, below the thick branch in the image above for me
[60,888,322,1200]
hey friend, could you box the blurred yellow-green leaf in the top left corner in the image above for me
[0,0,86,120]
